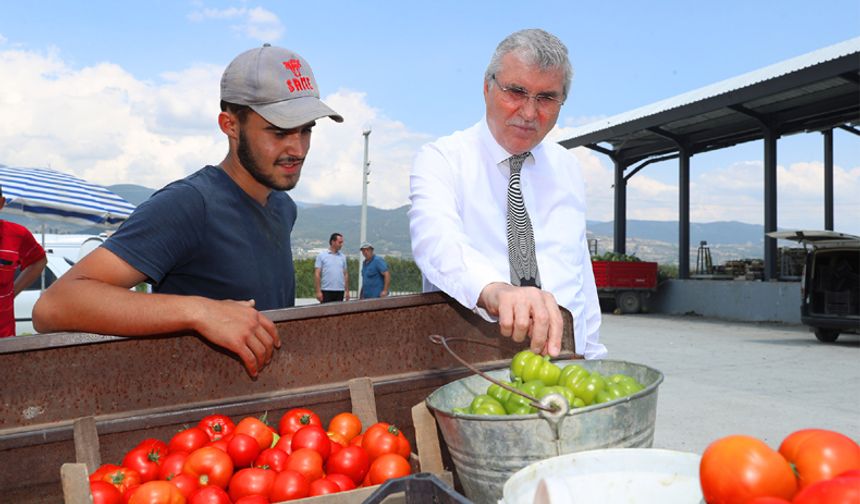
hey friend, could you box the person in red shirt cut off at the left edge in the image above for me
[0,186,48,338]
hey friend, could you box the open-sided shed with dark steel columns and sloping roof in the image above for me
[560,37,860,280]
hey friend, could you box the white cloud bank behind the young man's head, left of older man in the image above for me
[0,47,431,208]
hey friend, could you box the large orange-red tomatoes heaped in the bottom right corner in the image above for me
[699,429,860,504]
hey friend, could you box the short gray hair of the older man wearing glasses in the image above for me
[484,28,573,97]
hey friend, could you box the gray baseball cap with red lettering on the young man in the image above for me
[221,44,343,129]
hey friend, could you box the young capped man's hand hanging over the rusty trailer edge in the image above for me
[197,299,281,377]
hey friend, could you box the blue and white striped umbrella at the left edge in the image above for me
[0,165,134,228]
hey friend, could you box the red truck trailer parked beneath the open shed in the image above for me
[591,261,657,313]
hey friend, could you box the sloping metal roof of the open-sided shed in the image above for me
[560,37,860,166]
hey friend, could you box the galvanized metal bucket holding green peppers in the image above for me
[426,360,663,504]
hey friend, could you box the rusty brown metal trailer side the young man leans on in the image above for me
[0,293,575,503]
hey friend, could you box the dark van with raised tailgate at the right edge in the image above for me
[768,230,860,343]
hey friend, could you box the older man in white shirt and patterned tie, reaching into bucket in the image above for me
[409,29,606,358]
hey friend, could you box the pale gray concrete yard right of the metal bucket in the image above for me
[600,313,860,454]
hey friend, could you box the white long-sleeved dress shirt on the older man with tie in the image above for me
[409,118,606,359]
